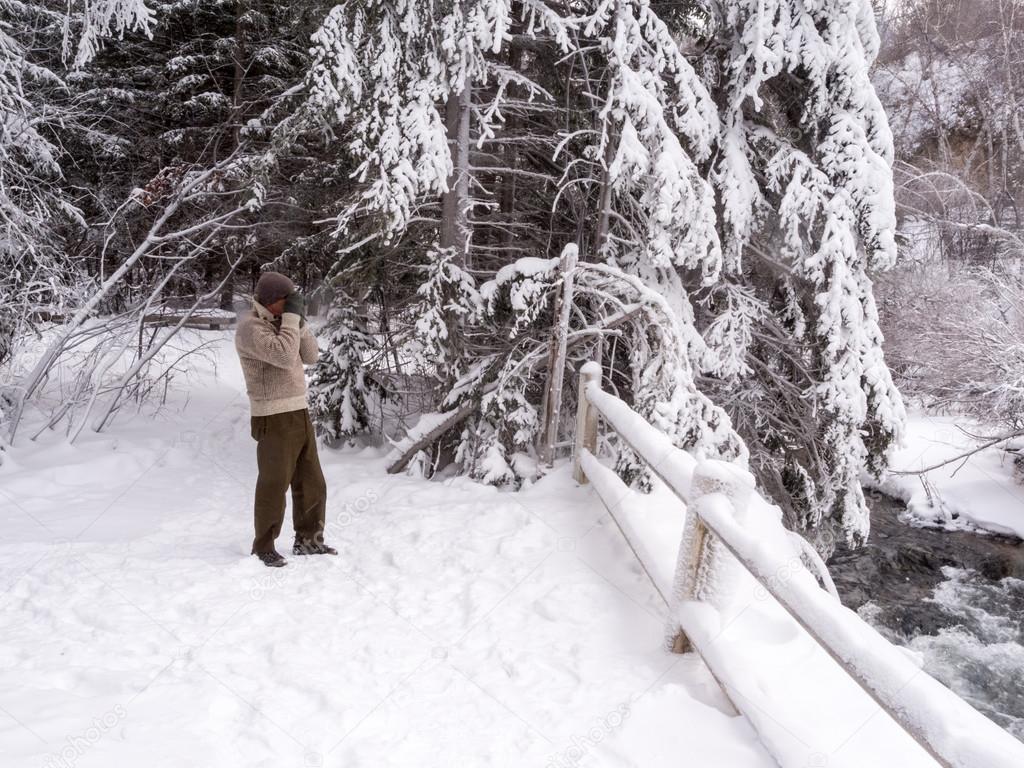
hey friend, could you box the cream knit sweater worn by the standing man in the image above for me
[234,300,319,416]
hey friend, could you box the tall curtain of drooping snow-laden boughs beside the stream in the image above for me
[708,0,904,549]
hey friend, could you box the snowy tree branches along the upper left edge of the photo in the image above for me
[0,0,159,440]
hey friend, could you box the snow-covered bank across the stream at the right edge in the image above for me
[866,412,1024,539]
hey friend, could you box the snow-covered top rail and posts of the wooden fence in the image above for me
[573,362,1024,768]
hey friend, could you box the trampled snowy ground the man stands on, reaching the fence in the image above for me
[0,332,1015,768]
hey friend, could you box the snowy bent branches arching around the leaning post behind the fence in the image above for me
[403,253,744,486]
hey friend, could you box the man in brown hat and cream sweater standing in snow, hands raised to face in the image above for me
[234,272,338,567]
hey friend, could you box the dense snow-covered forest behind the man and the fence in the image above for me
[0,0,1024,550]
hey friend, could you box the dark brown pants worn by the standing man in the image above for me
[252,409,327,554]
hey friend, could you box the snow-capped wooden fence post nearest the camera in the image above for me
[666,461,754,653]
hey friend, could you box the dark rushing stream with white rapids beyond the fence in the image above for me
[828,493,1024,740]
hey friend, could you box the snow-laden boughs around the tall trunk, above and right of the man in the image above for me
[308,0,566,239]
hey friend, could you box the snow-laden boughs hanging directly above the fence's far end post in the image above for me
[581,0,721,278]
